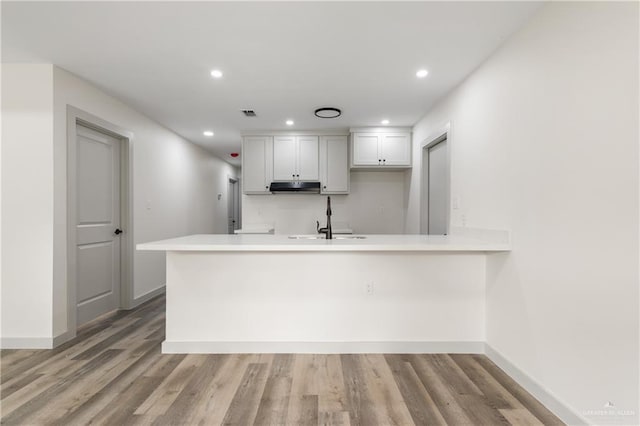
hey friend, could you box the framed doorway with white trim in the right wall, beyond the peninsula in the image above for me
[420,125,451,235]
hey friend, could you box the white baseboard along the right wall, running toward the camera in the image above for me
[485,343,591,425]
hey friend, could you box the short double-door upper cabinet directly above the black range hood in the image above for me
[273,136,320,181]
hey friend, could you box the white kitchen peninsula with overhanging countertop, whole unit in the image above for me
[137,231,510,353]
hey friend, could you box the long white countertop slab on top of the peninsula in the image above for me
[137,234,511,252]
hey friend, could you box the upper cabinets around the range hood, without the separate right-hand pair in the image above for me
[242,136,349,194]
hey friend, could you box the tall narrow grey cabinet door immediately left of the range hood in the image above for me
[242,136,273,194]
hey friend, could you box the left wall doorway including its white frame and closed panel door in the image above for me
[64,106,133,340]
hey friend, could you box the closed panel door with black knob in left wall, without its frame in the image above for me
[76,124,121,326]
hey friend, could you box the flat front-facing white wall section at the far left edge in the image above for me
[1,64,53,345]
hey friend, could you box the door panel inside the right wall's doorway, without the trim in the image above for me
[428,139,449,235]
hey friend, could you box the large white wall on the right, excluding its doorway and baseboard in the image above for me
[407,2,639,424]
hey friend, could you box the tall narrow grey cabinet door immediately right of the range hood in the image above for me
[320,136,349,194]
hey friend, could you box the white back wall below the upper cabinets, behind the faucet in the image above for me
[242,171,407,234]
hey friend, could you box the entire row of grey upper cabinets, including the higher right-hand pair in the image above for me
[242,129,411,194]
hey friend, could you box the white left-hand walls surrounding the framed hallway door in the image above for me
[2,64,237,345]
